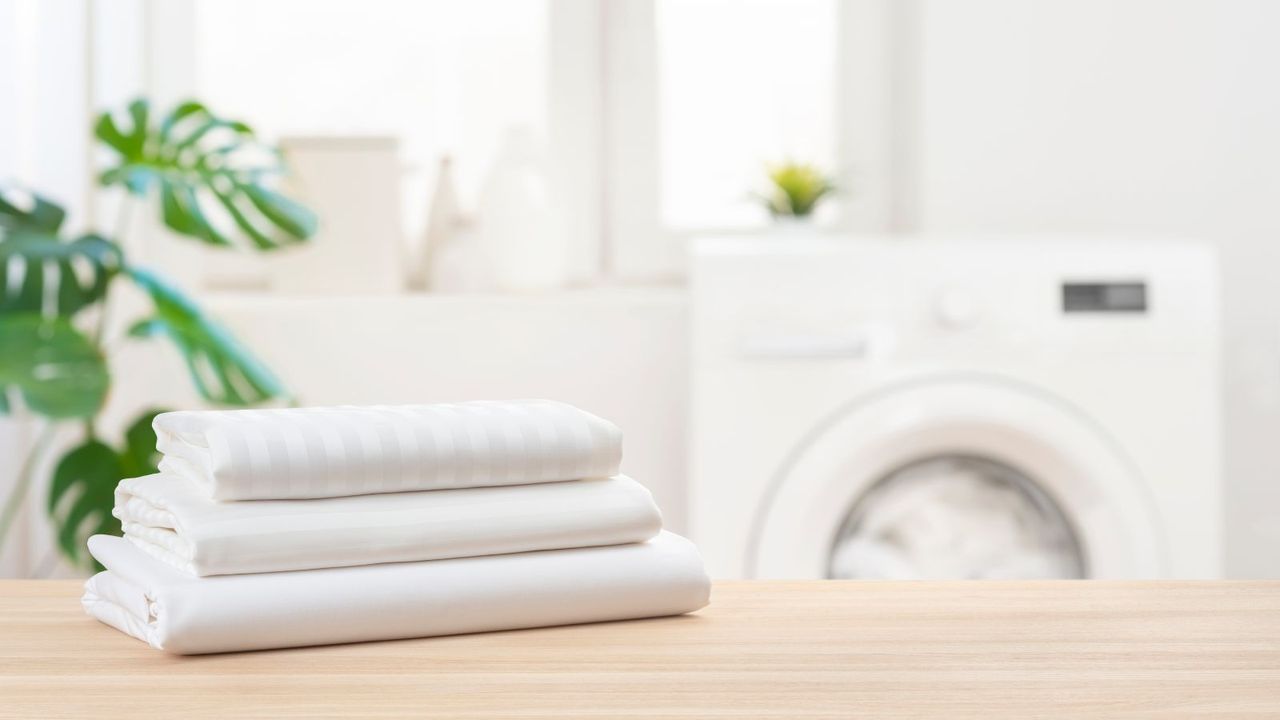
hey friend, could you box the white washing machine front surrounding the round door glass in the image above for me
[689,237,1222,578]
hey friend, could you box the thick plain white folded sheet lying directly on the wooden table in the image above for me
[82,532,710,655]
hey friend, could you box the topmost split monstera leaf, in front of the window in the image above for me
[95,100,316,250]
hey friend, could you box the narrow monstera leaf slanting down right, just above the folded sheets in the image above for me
[128,268,284,405]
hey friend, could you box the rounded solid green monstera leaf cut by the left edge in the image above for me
[0,313,110,419]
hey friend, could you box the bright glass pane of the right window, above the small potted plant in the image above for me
[655,0,837,229]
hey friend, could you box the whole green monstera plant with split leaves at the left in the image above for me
[0,100,316,565]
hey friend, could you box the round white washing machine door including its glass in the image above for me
[749,377,1166,579]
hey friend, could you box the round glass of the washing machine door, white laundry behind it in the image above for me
[827,455,1087,579]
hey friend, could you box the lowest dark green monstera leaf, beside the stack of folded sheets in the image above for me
[47,409,163,565]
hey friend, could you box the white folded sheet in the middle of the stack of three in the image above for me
[113,474,662,575]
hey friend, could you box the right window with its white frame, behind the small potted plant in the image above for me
[602,0,890,279]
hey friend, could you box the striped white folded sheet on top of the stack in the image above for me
[154,400,622,500]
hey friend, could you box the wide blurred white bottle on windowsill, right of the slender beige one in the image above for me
[477,128,568,291]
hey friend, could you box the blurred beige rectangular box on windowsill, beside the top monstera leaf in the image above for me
[271,137,404,293]
